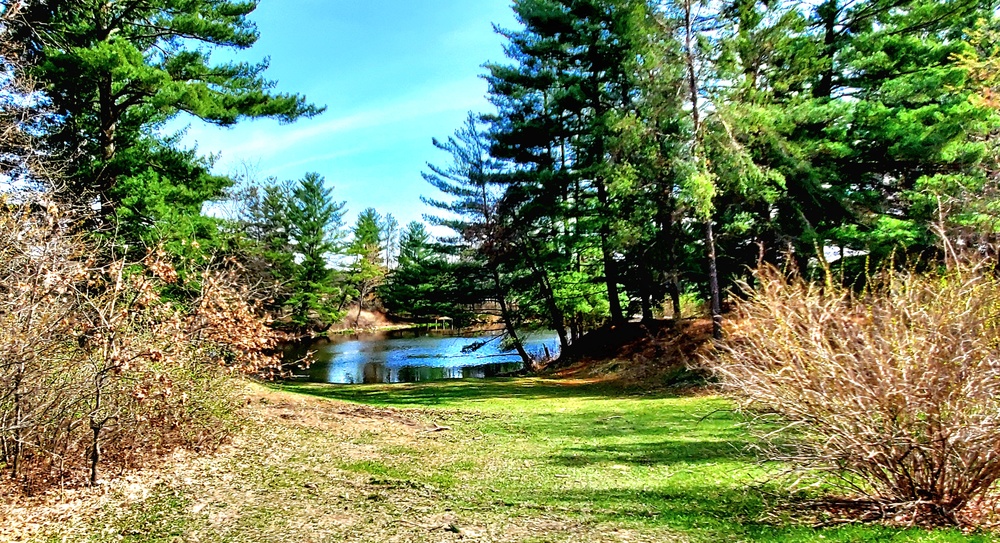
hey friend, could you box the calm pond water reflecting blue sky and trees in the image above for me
[286,330,559,383]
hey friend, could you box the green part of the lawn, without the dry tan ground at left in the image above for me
[284,379,993,542]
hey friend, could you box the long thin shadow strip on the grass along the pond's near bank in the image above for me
[275,378,667,407]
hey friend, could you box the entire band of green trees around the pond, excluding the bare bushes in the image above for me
[4,0,997,348]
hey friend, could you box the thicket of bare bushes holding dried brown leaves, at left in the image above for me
[0,203,281,489]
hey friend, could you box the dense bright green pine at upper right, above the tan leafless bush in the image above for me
[719,0,995,269]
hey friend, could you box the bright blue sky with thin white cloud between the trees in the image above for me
[180,0,515,230]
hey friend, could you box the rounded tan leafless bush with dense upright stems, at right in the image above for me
[711,259,1000,522]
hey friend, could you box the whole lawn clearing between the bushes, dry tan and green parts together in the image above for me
[29,379,994,543]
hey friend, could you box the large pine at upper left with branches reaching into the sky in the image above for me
[10,0,321,237]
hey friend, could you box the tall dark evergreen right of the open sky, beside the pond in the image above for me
[487,0,652,323]
